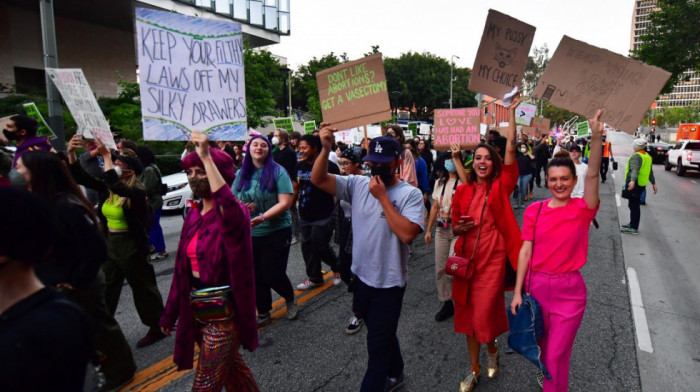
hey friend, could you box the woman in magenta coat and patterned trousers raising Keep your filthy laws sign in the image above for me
[160,131,259,392]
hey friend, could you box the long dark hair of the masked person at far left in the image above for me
[21,151,97,222]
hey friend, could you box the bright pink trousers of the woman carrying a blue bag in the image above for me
[530,271,586,392]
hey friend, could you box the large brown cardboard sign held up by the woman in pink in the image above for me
[532,36,671,134]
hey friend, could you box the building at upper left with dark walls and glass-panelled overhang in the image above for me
[0,0,290,97]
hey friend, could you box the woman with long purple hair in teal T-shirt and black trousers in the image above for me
[232,135,298,326]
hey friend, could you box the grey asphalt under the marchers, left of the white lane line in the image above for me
[112,158,644,392]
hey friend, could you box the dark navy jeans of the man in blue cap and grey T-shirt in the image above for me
[353,278,406,392]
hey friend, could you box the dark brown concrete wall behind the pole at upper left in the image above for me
[0,4,136,97]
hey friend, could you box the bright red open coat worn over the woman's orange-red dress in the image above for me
[452,163,523,290]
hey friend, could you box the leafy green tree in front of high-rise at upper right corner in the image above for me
[632,0,700,94]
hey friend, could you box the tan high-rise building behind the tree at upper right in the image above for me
[630,0,700,107]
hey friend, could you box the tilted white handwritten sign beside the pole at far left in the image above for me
[46,68,117,149]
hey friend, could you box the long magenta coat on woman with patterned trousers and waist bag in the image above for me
[160,185,258,370]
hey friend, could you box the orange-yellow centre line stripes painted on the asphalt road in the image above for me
[120,271,333,392]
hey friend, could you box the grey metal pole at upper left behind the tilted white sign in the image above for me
[39,0,66,151]
